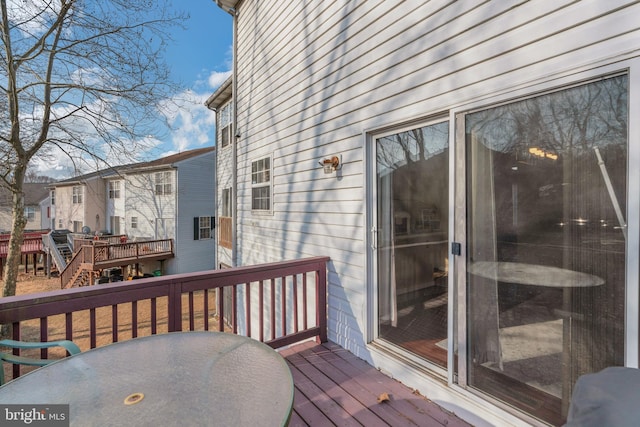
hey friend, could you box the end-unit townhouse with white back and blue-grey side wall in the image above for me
[112,147,216,274]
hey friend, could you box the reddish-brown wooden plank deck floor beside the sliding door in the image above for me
[281,342,469,427]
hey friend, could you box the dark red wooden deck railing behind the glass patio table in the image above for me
[0,257,329,378]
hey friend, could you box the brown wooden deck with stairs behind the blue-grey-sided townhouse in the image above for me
[60,235,175,288]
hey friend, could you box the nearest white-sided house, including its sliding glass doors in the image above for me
[207,0,640,425]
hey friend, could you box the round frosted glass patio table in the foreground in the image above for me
[0,332,293,427]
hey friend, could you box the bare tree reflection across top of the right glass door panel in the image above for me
[466,75,627,154]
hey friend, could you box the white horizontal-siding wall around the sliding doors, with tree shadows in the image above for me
[234,0,640,424]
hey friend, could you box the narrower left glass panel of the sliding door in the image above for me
[373,121,449,367]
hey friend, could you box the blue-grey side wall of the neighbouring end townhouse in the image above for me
[175,151,216,273]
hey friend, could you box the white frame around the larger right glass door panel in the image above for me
[449,58,640,398]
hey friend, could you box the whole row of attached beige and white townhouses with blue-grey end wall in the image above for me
[51,147,216,280]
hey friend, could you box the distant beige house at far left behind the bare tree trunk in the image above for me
[0,182,49,233]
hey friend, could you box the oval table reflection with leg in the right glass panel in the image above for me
[468,261,604,414]
